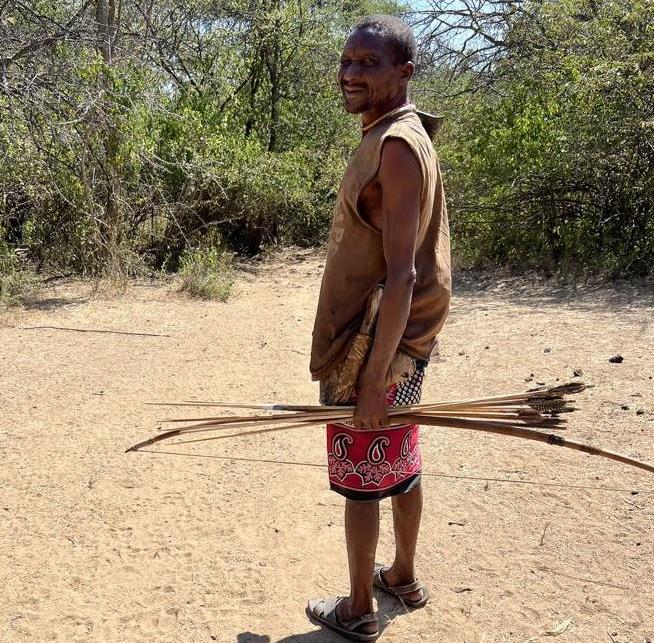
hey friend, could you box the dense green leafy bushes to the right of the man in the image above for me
[420,0,654,276]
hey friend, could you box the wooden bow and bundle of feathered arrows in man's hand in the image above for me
[127,383,654,473]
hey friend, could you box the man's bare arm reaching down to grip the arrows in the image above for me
[354,139,422,429]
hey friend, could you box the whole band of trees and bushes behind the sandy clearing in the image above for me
[0,0,654,297]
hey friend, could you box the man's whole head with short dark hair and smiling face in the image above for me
[338,15,416,114]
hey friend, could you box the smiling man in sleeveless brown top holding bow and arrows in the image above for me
[307,16,451,641]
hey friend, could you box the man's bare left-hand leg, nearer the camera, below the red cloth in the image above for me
[338,499,379,632]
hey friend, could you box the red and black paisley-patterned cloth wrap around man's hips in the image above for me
[327,364,424,501]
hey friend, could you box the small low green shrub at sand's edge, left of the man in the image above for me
[179,247,234,301]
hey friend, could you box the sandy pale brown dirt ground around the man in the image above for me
[0,253,654,643]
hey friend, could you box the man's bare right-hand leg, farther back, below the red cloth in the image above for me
[384,484,422,601]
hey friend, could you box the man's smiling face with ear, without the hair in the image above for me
[338,31,413,114]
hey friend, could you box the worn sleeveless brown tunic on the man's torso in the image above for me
[310,109,451,380]
